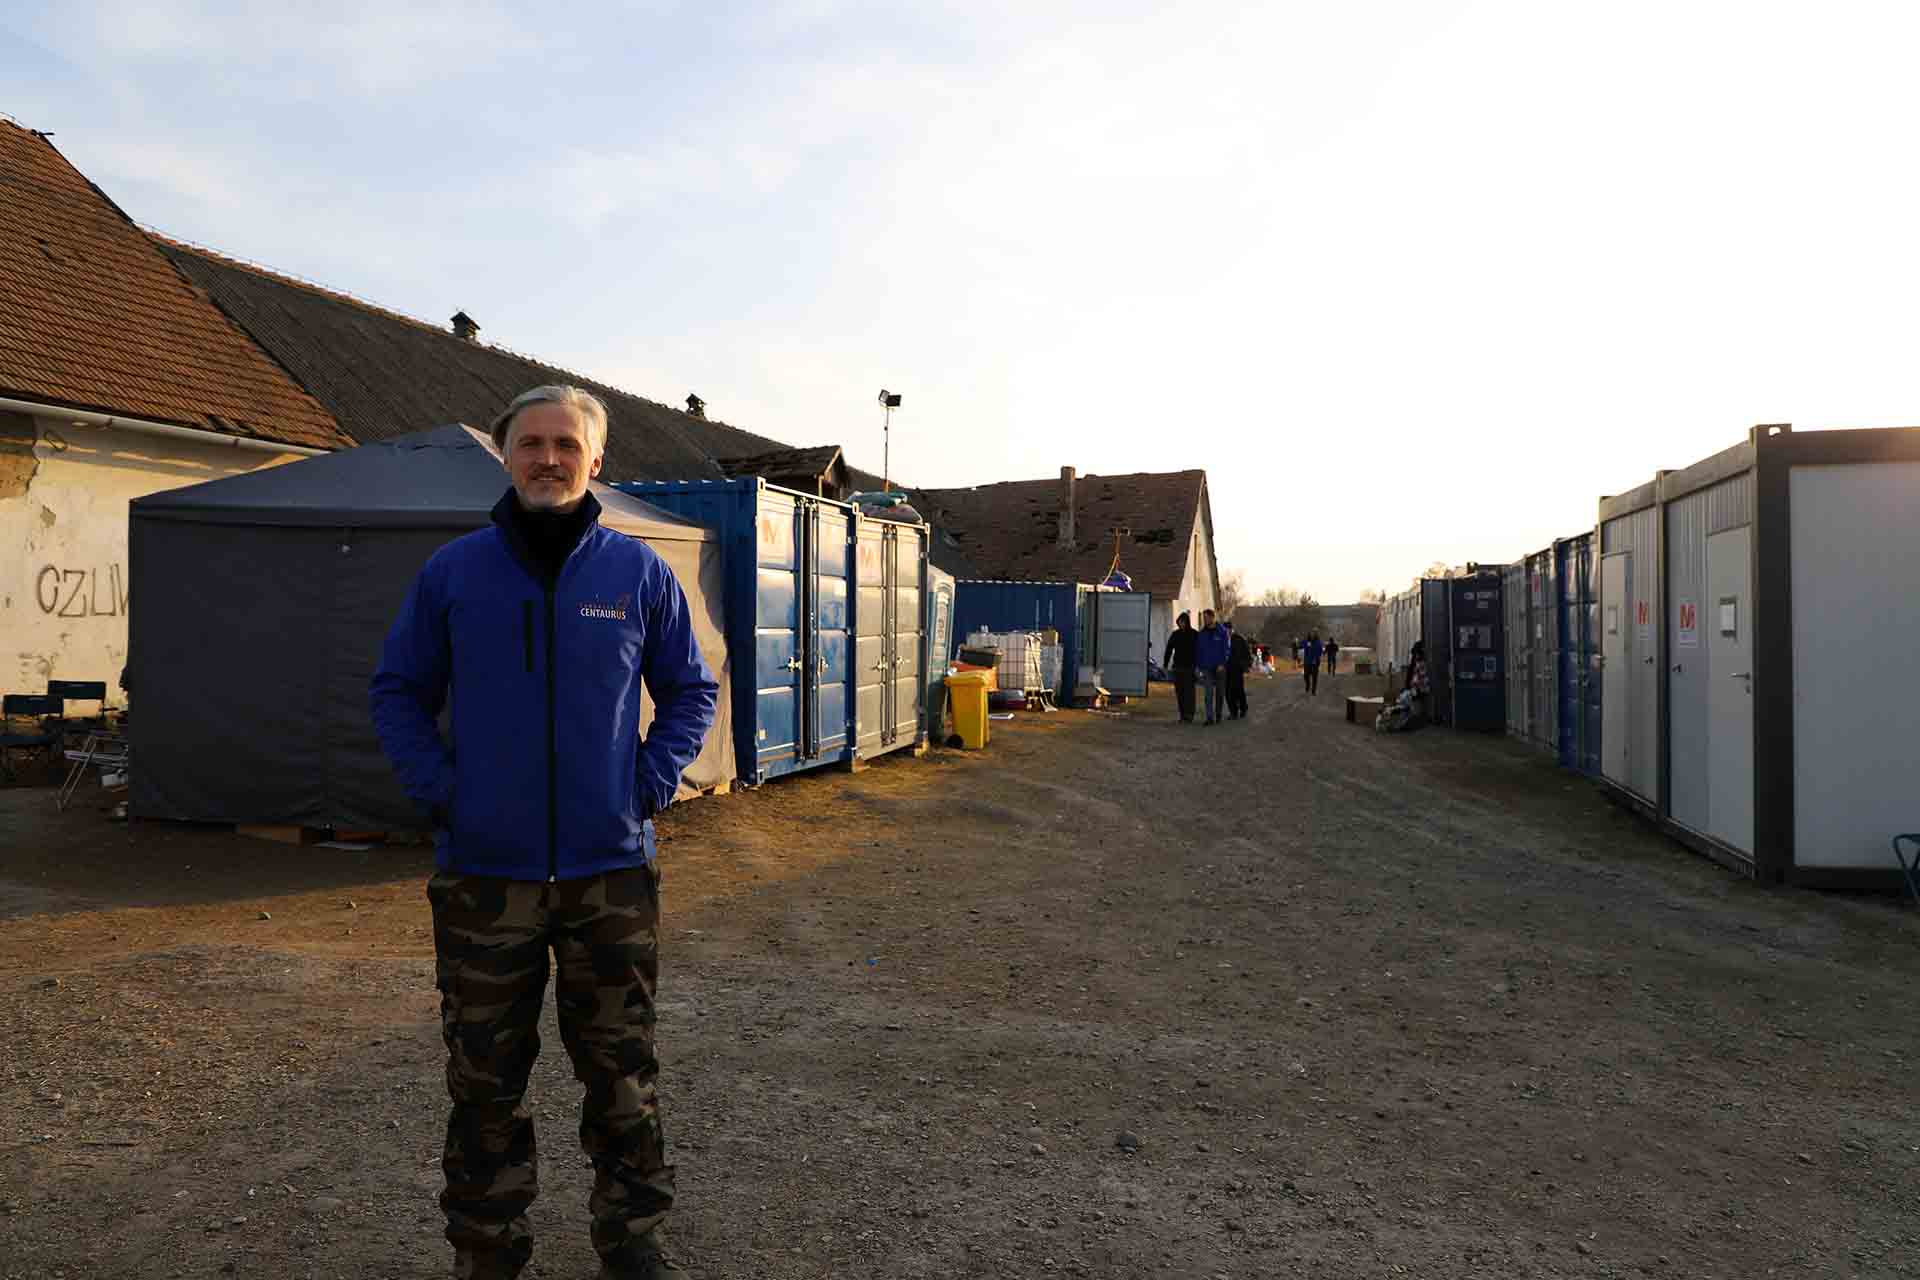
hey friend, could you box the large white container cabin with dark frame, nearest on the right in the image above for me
[1599,426,1920,887]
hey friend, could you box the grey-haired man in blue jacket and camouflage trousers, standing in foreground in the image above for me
[372,386,718,1280]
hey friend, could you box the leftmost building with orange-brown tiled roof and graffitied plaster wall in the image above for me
[0,117,351,702]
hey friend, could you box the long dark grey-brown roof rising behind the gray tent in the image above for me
[156,238,787,482]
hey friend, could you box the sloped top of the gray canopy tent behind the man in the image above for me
[132,424,716,541]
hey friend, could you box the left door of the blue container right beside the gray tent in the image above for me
[753,493,806,777]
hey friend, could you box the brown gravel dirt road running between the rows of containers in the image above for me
[0,677,1920,1280]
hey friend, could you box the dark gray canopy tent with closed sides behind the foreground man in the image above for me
[129,426,735,831]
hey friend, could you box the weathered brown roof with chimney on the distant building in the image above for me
[912,470,1212,599]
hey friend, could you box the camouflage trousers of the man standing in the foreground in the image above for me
[426,867,674,1280]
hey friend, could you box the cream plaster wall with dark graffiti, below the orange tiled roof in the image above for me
[0,415,298,710]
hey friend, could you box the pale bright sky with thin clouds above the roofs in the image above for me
[0,0,1920,603]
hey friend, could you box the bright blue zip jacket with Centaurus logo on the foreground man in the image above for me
[371,493,720,881]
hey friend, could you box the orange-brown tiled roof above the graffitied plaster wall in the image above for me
[0,119,351,449]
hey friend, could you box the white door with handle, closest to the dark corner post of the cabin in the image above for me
[1699,528,1753,854]
